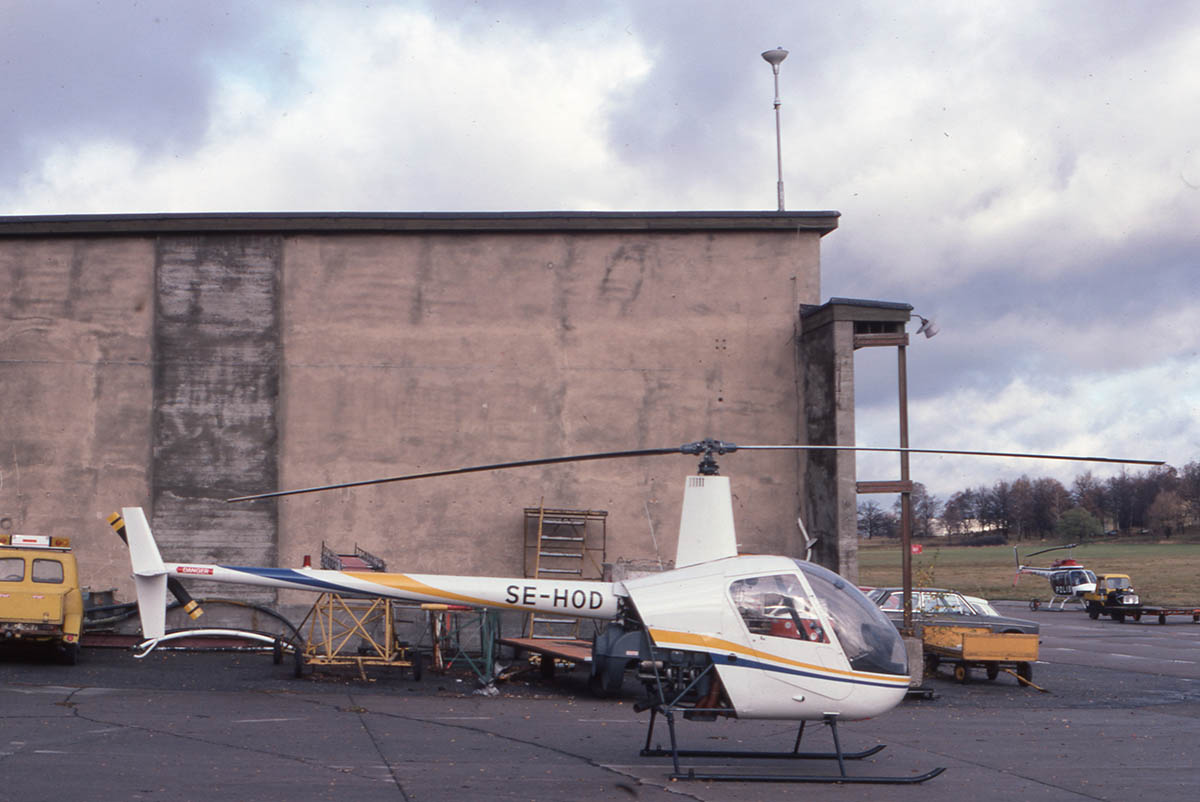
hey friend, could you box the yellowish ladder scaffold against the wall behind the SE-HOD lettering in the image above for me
[524,505,608,639]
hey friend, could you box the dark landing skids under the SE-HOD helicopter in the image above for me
[641,705,946,785]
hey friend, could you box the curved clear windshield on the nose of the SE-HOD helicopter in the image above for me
[796,559,908,675]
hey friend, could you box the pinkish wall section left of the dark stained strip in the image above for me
[0,237,155,588]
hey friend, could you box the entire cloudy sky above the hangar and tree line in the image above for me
[0,0,1200,497]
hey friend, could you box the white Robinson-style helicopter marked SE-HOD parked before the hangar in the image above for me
[122,439,1156,784]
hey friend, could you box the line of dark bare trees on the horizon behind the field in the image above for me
[858,462,1200,540]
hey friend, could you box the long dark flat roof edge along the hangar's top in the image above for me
[0,211,841,237]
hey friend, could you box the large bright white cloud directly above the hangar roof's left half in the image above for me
[5,6,649,213]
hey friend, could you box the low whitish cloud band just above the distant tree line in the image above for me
[857,359,1200,501]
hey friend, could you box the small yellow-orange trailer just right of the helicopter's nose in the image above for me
[922,624,1038,684]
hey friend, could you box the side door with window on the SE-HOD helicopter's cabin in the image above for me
[720,574,850,718]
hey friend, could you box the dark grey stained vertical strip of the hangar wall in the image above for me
[151,234,283,602]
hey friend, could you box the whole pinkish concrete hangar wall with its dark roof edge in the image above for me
[0,211,838,598]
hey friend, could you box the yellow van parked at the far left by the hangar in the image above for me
[0,534,83,665]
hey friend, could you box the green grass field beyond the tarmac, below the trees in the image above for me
[858,540,1200,606]
